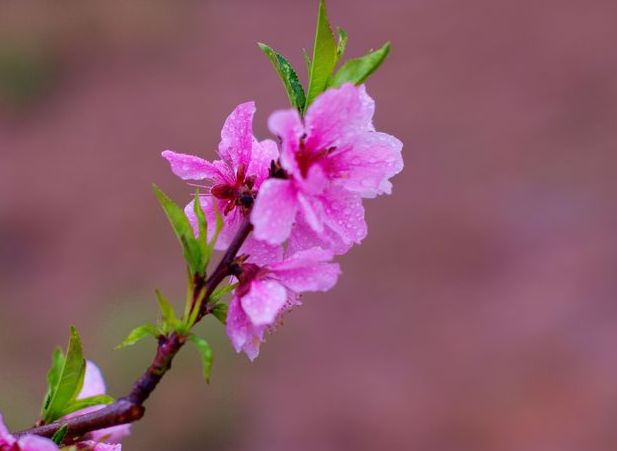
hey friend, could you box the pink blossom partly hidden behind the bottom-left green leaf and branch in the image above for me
[65,360,131,451]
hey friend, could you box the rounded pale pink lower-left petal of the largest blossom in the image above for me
[251,179,298,244]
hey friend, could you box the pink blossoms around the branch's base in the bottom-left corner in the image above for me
[0,361,131,451]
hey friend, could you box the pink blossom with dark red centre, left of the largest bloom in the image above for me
[162,102,279,261]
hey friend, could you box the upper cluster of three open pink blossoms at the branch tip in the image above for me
[163,83,403,360]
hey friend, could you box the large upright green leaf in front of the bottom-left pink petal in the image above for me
[42,327,86,423]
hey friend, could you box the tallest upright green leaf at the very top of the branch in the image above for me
[304,0,337,111]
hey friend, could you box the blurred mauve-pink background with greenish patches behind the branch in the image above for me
[0,0,617,451]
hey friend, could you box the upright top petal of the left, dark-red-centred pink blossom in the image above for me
[219,102,255,170]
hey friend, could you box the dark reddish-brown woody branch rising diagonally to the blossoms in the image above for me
[14,215,253,439]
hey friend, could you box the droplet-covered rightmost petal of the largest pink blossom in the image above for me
[328,132,403,197]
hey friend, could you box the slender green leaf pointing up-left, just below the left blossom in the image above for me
[153,185,207,274]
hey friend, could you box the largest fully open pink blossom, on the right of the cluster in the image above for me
[251,84,403,254]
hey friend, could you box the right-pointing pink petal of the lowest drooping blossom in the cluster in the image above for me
[271,248,341,293]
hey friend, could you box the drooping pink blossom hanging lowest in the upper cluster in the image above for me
[227,248,340,360]
